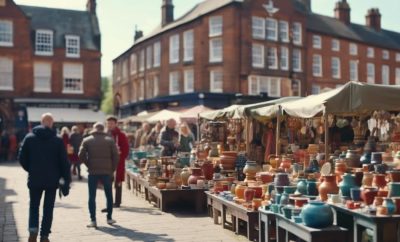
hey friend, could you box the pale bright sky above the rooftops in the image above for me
[14,0,400,76]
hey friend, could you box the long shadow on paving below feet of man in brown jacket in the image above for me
[97,225,175,242]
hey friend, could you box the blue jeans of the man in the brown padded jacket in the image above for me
[88,175,113,221]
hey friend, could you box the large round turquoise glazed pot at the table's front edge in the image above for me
[301,201,333,228]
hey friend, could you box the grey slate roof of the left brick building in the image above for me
[19,5,100,51]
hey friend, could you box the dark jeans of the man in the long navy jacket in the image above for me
[29,188,57,238]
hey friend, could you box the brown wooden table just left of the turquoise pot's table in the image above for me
[206,192,259,241]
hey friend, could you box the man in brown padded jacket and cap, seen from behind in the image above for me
[78,123,119,228]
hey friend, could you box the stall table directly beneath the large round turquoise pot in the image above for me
[259,209,348,242]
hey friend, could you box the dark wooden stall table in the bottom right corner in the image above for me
[330,204,400,242]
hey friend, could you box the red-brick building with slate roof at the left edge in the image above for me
[0,0,101,136]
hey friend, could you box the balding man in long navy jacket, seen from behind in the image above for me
[19,113,71,242]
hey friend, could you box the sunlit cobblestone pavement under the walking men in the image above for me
[0,162,248,242]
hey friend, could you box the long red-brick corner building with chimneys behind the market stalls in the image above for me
[113,0,400,114]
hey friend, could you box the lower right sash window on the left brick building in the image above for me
[63,63,83,93]
